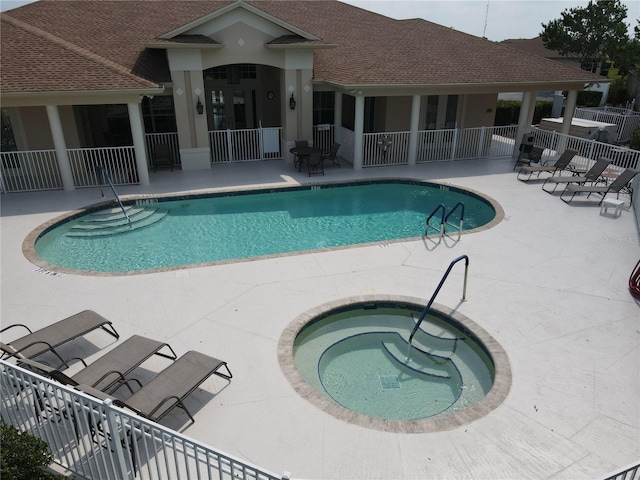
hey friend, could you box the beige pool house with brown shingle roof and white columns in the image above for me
[0,0,601,191]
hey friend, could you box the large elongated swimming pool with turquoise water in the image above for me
[26,180,501,274]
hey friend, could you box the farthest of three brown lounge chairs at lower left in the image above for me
[0,310,120,362]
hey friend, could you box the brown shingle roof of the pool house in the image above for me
[0,0,601,92]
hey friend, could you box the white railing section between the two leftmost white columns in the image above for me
[67,147,138,188]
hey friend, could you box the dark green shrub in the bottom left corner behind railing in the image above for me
[0,423,63,480]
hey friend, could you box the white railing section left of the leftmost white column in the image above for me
[0,150,63,192]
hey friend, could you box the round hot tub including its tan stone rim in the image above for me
[278,295,511,433]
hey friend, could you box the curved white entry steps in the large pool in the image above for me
[65,205,169,237]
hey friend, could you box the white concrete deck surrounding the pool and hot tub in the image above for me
[0,159,640,479]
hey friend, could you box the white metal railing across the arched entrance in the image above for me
[209,127,282,163]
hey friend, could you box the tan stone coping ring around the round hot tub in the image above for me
[278,294,512,433]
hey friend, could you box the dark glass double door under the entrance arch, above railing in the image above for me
[206,87,256,130]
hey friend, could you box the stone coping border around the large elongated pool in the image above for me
[22,177,505,277]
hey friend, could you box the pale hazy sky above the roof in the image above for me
[0,0,640,41]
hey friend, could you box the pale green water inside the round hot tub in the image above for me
[293,307,494,420]
